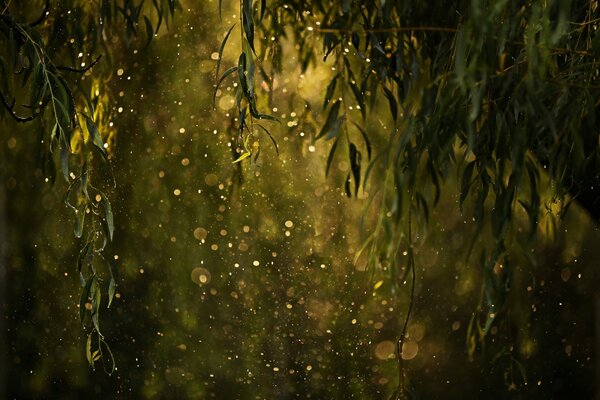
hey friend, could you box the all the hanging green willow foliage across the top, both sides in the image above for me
[0,0,600,398]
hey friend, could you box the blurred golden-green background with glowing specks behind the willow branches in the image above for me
[0,1,600,399]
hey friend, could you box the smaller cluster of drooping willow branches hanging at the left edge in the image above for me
[0,0,176,373]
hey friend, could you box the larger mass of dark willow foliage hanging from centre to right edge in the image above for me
[217,0,600,397]
